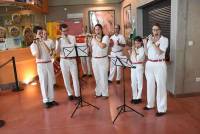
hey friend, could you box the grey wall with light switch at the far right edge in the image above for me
[183,0,200,93]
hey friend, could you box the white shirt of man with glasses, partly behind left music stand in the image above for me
[56,35,76,57]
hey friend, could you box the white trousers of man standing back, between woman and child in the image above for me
[108,51,123,81]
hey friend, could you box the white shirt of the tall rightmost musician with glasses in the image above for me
[147,36,169,60]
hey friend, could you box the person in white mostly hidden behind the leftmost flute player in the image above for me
[43,29,56,85]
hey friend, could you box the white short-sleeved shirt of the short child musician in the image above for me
[131,47,145,68]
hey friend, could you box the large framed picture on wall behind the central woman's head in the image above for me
[88,10,115,35]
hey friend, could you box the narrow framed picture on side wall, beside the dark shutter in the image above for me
[123,4,132,39]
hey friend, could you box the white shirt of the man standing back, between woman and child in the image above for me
[110,34,126,52]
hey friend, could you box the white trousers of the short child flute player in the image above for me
[131,66,144,100]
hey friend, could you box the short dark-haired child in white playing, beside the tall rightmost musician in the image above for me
[130,36,145,104]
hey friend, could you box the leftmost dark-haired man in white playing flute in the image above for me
[30,26,58,108]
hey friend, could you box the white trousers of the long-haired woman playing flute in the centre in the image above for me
[92,57,108,96]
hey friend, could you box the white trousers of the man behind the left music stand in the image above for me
[60,58,80,97]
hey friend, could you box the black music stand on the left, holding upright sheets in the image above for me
[63,42,99,118]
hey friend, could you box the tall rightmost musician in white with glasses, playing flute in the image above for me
[144,24,168,116]
